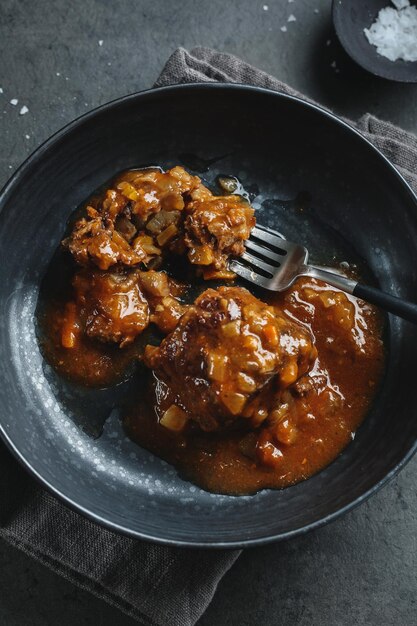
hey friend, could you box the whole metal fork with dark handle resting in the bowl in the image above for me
[230,224,417,324]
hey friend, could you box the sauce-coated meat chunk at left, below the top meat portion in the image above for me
[62,270,149,348]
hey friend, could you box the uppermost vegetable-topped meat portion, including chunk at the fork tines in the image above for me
[62,166,255,278]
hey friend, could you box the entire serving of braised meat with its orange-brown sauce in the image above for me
[39,168,384,495]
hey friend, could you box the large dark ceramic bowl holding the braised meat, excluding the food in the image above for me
[0,84,417,547]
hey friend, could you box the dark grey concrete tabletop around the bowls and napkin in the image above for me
[0,0,417,626]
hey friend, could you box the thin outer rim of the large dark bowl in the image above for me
[0,82,417,549]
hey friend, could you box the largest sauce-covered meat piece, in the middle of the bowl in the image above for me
[145,287,317,431]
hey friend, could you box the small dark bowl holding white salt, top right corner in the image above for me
[332,0,417,83]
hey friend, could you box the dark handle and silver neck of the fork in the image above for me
[306,265,417,324]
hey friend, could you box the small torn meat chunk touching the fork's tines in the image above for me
[184,191,255,279]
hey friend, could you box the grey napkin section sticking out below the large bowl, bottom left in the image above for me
[0,444,239,626]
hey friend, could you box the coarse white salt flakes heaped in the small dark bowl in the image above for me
[364,0,417,61]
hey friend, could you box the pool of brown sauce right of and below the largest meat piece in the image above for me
[125,279,384,495]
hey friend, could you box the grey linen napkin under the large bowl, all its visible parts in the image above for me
[0,48,417,626]
